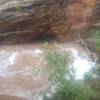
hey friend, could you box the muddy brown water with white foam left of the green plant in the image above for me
[0,44,47,100]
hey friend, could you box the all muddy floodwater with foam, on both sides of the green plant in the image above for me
[0,43,94,100]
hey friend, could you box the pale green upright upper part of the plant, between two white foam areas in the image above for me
[45,50,68,82]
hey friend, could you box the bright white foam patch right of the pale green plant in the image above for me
[63,48,94,79]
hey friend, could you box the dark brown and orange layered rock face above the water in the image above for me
[0,0,97,43]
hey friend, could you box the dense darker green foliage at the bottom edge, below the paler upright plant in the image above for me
[44,80,91,100]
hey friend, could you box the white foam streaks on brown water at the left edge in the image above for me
[0,49,43,77]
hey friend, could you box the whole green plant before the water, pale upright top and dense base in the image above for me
[43,50,91,100]
